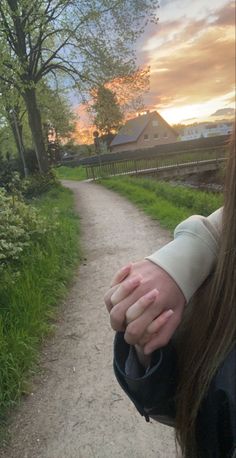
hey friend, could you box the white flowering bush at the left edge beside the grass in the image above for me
[0,188,52,272]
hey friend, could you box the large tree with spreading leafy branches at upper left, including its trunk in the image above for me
[0,0,157,172]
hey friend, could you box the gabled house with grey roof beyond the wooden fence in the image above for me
[110,111,178,153]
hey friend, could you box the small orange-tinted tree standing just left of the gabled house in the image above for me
[92,86,124,135]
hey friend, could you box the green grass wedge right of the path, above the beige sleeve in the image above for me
[100,177,222,231]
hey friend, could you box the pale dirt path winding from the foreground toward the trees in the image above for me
[0,182,176,458]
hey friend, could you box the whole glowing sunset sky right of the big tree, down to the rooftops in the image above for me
[73,0,235,142]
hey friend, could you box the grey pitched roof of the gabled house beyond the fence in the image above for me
[110,111,176,146]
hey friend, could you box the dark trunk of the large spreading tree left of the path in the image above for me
[23,88,49,173]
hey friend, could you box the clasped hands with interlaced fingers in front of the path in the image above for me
[105,260,185,353]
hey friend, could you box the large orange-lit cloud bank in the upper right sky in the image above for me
[143,1,235,112]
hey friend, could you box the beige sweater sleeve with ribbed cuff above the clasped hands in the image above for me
[146,208,222,302]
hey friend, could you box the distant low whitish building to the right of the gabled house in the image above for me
[180,122,233,141]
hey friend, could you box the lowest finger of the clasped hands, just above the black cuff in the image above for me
[144,313,180,355]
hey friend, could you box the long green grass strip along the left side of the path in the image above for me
[0,186,80,428]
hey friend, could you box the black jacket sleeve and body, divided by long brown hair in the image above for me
[114,333,236,458]
